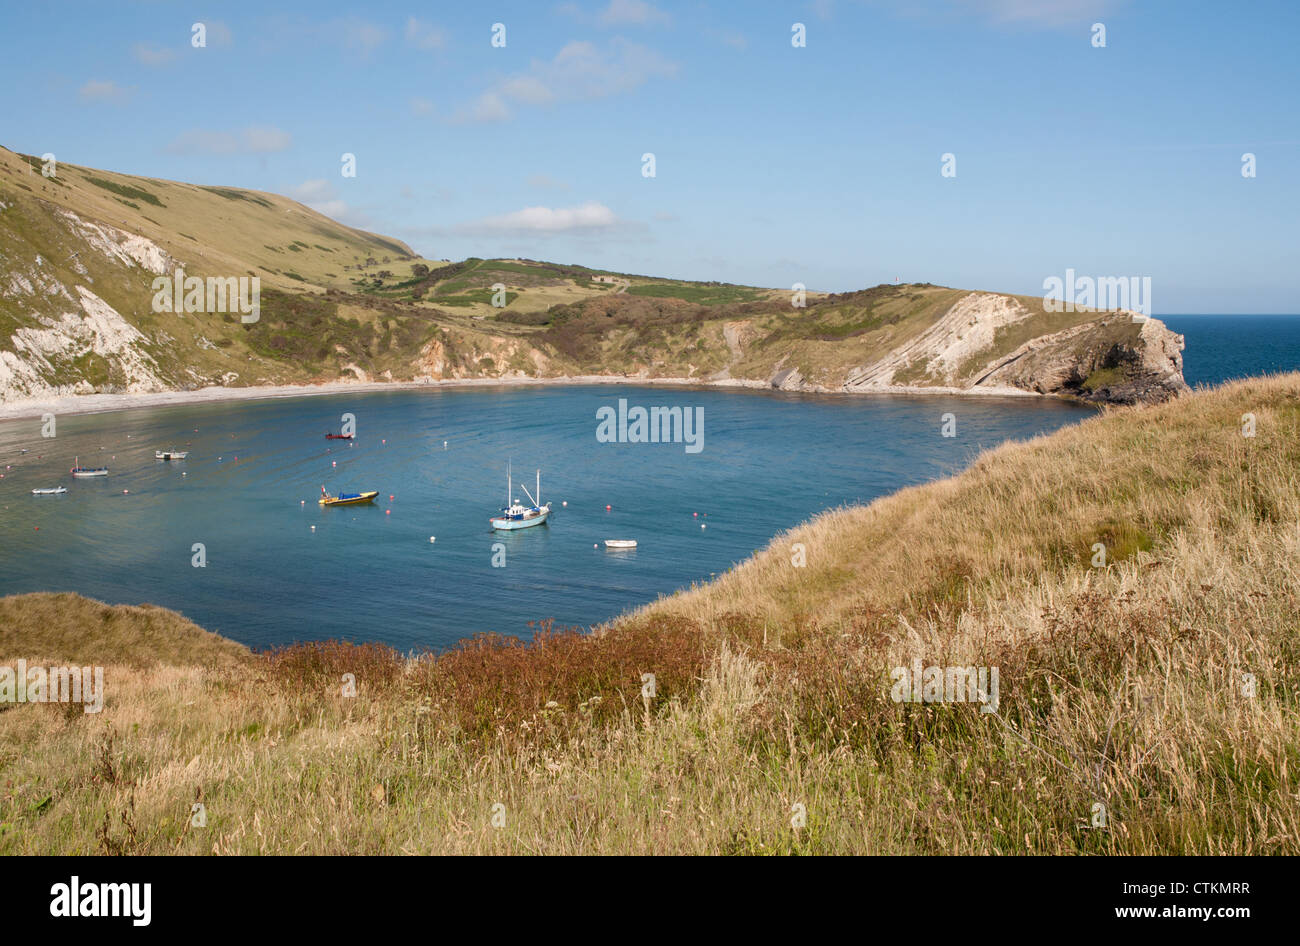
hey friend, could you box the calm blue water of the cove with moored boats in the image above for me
[0,386,1091,650]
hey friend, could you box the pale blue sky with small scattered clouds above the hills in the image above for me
[0,0,1300,314]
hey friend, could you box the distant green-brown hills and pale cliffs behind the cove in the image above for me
[0,148,1182,400]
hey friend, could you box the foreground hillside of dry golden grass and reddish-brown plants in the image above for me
[0,374,1300,855]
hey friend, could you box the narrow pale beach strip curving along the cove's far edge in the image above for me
[0,374,1055,421]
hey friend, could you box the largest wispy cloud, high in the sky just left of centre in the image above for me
[452,39,677,122]
